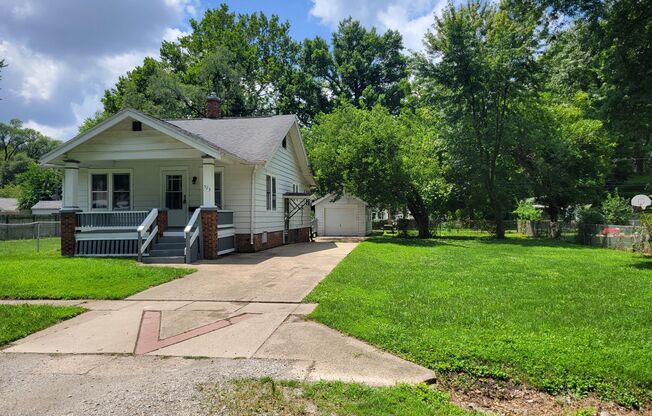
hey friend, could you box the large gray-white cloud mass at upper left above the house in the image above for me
[0,0,194,140]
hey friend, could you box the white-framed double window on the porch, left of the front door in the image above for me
[90,172,131,211]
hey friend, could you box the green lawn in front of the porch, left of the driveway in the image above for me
[0,238,194,299]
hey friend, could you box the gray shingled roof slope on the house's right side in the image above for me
[165,115,296,162]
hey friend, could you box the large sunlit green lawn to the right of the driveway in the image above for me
[306,237,652,406]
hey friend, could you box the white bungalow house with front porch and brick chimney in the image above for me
[41,96,315,262]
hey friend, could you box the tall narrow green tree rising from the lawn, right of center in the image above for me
[416,1,539,238]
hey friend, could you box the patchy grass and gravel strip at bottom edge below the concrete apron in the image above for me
[199,378,475,416]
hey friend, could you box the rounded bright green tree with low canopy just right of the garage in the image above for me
[305,103,450,237]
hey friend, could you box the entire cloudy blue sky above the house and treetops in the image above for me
[0,0,446,140]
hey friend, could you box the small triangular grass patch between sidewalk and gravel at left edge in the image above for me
[0,305,84,346]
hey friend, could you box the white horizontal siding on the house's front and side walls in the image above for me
[68,119,310,234]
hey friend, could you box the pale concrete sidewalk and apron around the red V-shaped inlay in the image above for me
[3,301,434,385]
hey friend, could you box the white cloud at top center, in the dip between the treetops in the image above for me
[310,0,446,50]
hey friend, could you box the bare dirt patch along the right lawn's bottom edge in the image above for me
[434,374,652,416]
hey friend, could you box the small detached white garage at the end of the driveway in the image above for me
[312,194,371,236]
